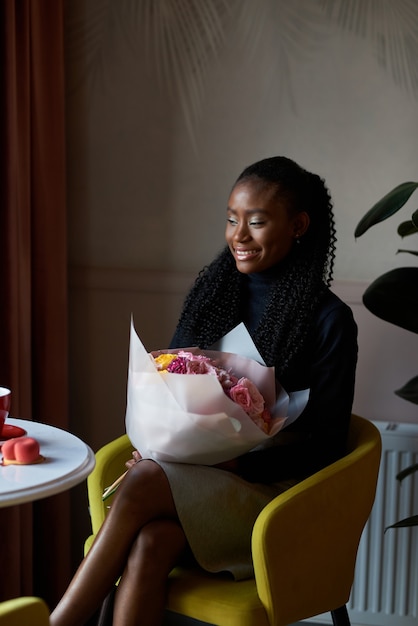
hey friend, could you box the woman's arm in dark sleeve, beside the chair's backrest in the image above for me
[238,299,357,482]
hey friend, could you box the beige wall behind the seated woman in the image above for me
[66,0,418,448]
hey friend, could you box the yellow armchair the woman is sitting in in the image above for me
[85,415,381,626]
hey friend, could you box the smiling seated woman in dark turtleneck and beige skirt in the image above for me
[51,157,357,626]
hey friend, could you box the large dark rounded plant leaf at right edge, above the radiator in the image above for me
[363,267,418,334]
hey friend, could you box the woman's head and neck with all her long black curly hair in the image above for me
[171,157,336,364]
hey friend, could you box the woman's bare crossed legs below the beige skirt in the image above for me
[50,460,187,626]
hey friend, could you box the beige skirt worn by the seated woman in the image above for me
[158,461,296,580]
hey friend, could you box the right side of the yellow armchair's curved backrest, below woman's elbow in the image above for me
[252,415,381,625]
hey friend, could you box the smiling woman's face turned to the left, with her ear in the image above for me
[225,181,309,274]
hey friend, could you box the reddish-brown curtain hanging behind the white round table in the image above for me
[0,0,70,605]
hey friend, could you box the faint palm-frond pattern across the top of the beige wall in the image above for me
[66,0,418,143]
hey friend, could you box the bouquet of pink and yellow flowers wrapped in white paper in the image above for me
[126,323,307,465]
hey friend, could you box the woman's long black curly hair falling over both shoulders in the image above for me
[173,156,336,375]
